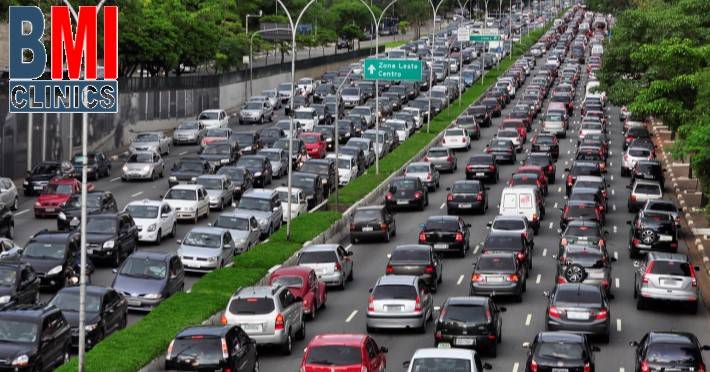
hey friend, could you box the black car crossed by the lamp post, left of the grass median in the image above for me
[49,285,128,348]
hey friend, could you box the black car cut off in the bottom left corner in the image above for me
[0,305,71,371]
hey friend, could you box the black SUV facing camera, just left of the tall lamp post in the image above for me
[20,230,80,289]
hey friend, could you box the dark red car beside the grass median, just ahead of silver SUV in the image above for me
[269,266,327,319]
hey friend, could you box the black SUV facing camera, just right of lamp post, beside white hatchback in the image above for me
[86,212,138,267]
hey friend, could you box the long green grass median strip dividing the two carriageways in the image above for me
[57,25,549,372]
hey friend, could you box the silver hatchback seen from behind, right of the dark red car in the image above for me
[367,275,434,333]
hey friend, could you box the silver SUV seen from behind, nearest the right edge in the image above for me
[634,252,699,313]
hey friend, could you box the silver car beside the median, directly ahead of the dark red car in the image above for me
[296,244,353,289]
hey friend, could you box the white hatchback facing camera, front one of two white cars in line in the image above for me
[124,199,177,244]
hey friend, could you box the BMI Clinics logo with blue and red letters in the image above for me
[8,2,118,113]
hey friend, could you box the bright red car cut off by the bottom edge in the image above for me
[300,334,387,372]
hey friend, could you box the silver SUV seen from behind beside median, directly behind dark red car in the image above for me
[221,285,306,355]
